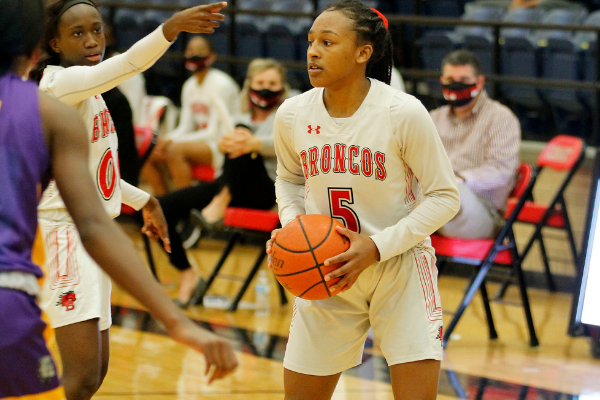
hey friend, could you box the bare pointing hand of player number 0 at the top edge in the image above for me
[163,1,227,42]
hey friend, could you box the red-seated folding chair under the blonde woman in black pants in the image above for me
[190,207,287,311]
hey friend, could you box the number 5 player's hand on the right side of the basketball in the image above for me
[325,226,379,292]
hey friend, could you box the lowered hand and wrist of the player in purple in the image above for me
[169,318,238,384]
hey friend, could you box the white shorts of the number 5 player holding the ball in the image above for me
[283,242,443,376]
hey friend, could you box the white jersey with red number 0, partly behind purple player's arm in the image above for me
[38,65,121,218]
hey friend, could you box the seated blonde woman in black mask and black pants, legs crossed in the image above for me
[159,59,289,306]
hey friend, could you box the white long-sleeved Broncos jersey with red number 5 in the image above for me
[275,79,459,261]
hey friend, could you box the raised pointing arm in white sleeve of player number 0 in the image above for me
[47,2,227,105]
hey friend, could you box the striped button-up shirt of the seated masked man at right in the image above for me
[431,91,521,210]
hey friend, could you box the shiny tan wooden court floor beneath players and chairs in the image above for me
[95,152,600,400]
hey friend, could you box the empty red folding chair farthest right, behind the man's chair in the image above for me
[497,135,585,297]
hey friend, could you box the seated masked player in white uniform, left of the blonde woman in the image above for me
[142,36,239,195]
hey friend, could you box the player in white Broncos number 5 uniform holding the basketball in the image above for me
[267,0,459,400]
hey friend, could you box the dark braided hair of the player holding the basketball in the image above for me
[325,0,393,85]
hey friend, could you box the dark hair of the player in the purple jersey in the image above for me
[0,0,44,76]
